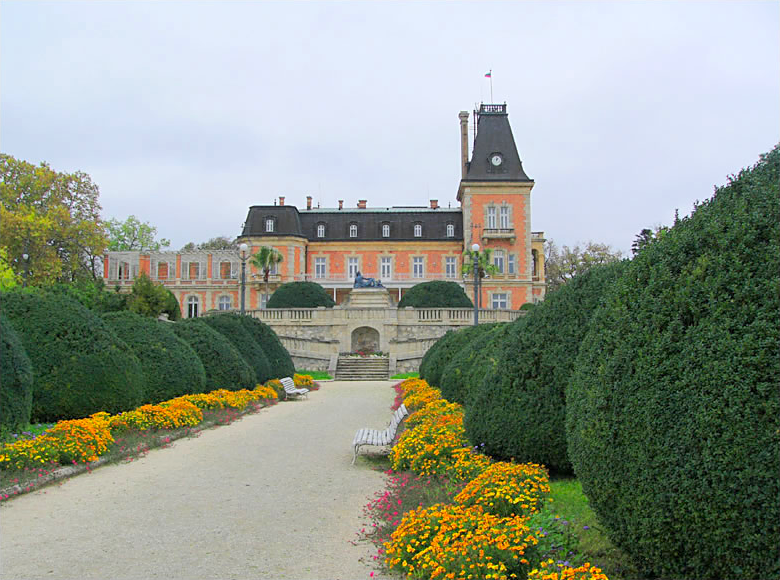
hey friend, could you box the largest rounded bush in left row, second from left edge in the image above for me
[2,292,144,422]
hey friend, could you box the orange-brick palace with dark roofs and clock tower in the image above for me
[104,104,545,317]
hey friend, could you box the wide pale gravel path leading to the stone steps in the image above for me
[0,381,402,580]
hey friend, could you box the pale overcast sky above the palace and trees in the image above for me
[0,0,780,253]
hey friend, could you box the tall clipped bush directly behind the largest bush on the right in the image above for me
[463,262,626,473]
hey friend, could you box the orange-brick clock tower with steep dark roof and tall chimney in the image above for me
[458,104,545,310]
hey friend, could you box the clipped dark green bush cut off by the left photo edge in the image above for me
[0,314,33,437]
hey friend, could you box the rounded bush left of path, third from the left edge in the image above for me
[102,311,206,403]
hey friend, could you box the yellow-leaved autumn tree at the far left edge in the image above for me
[0,154,107,286]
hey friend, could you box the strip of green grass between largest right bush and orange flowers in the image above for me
[550,478,641,580]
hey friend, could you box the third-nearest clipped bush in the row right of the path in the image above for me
[439,322,513,407]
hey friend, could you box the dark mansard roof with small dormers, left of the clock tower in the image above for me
[241,205,463,242]
